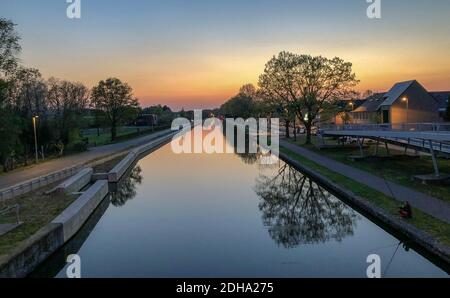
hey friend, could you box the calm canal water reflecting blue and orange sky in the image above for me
[34,132,448,278]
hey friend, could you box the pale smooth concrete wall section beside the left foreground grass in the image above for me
[52,180,108,242]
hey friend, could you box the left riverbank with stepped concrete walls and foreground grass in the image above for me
[0,133,178,277]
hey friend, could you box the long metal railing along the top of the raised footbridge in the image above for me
[320,123,450,133]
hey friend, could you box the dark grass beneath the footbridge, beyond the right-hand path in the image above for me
[292,136,450,203]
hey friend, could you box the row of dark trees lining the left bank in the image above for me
[0,19,140,171]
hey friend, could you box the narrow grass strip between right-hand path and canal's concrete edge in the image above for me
[280,148,450,246]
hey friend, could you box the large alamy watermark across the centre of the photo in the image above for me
[171,110,280,164]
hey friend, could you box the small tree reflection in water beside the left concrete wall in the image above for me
[111,166,142,207]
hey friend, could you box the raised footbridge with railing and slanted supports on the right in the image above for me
[318,123,450,177]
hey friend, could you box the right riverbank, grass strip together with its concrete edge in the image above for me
[280,147,450,265]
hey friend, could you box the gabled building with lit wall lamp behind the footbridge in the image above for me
[351,80,445,124]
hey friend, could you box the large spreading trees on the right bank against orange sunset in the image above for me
[220,51,359,144]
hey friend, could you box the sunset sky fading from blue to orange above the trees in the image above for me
[0,0,450,110]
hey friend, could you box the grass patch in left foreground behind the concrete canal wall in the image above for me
[0,183,76,255]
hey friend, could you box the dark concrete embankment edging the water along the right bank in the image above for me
[280,152,450,266]
